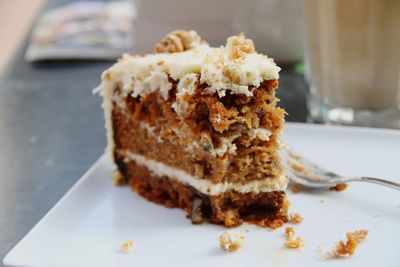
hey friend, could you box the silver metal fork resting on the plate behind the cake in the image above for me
[280,142,400,190]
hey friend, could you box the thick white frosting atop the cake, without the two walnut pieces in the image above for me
[99,38,280,99]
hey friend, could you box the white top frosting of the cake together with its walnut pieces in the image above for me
[102,31,280,99]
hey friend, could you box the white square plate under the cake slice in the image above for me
[4,123,400,267]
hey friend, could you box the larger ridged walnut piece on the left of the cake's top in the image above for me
[154,30,202,53]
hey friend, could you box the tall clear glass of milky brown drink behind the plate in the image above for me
[304,0,400,128]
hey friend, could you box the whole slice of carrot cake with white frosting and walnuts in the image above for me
[99,31,288,227]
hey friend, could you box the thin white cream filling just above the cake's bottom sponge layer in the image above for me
[125,151,288,196]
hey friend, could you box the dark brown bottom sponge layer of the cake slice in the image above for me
[118,161,289,228]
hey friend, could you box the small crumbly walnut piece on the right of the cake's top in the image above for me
[226,32,255,60]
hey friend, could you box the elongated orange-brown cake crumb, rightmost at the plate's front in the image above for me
[328,229,368,258]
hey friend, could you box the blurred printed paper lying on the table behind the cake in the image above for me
[25,1,136,62]
